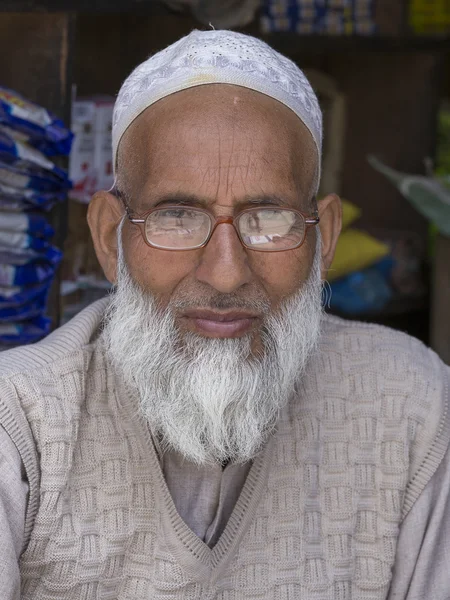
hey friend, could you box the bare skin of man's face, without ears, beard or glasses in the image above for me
[114,85,317,343]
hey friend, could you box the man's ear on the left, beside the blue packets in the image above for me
[87,191,124,283]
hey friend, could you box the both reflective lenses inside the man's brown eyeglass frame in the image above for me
[145,207,305,251]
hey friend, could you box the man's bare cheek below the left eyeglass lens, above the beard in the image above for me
[123,228,195,305]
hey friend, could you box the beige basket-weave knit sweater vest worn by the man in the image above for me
[0,302,450,600]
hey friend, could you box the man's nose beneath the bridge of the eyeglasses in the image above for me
[196,223,252,294]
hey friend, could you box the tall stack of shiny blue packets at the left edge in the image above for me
[0,87,73,349]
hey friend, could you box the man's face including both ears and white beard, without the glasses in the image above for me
[89,85,339,464]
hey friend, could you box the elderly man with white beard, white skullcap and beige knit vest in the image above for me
[0,31,450,600]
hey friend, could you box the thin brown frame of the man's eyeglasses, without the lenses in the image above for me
[114,189,320,252]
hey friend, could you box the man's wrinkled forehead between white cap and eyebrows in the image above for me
[119,84,316,205]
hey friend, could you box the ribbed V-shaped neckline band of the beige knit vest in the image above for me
[120,386,276,584]
